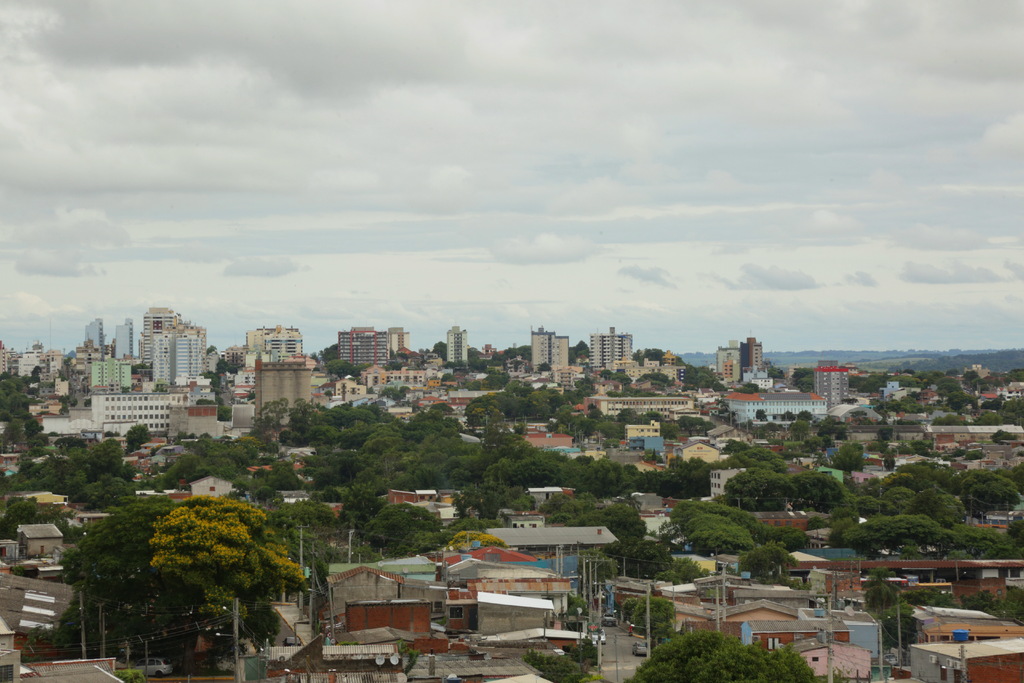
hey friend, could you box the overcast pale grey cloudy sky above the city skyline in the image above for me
[0,0,1024,358]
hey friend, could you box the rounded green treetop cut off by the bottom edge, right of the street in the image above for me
[630,631,815,683]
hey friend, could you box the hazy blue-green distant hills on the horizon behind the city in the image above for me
[678,348,1024,373]
